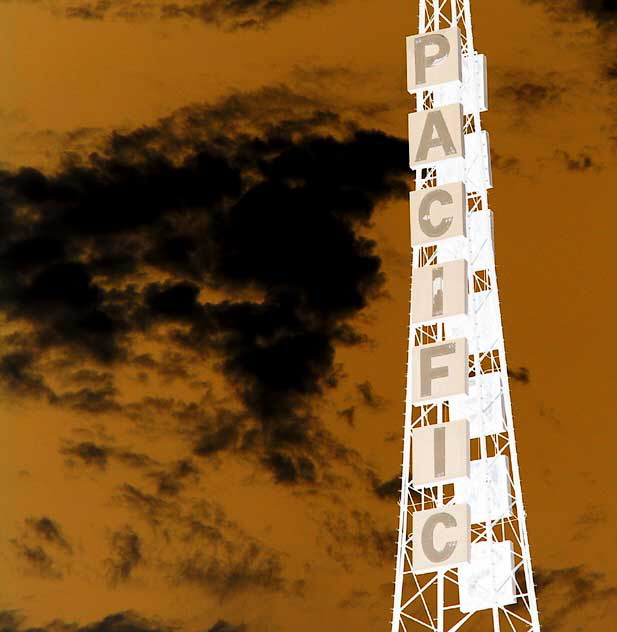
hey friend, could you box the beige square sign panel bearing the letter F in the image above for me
[411,338,469,404]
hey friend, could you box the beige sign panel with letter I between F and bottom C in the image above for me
[411,420,470,487]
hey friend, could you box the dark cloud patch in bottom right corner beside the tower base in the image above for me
[534,566,617,632]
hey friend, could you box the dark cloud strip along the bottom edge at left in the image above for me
[0,610,246,632]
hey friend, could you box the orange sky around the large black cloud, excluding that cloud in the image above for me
[0,0,617,632]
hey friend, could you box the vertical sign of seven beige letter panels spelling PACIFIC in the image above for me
[407,28,471,573]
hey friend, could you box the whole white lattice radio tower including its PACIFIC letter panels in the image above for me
[392,0,540,632]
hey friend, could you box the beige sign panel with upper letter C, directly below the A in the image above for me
[409,182,467,246]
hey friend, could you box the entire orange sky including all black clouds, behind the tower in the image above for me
[0,0,617,632]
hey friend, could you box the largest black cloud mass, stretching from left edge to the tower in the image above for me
[0,88,408,482]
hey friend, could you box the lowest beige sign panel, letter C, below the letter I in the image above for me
[412,505,471,573]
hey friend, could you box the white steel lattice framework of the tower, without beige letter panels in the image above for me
[391,0,540,632]
